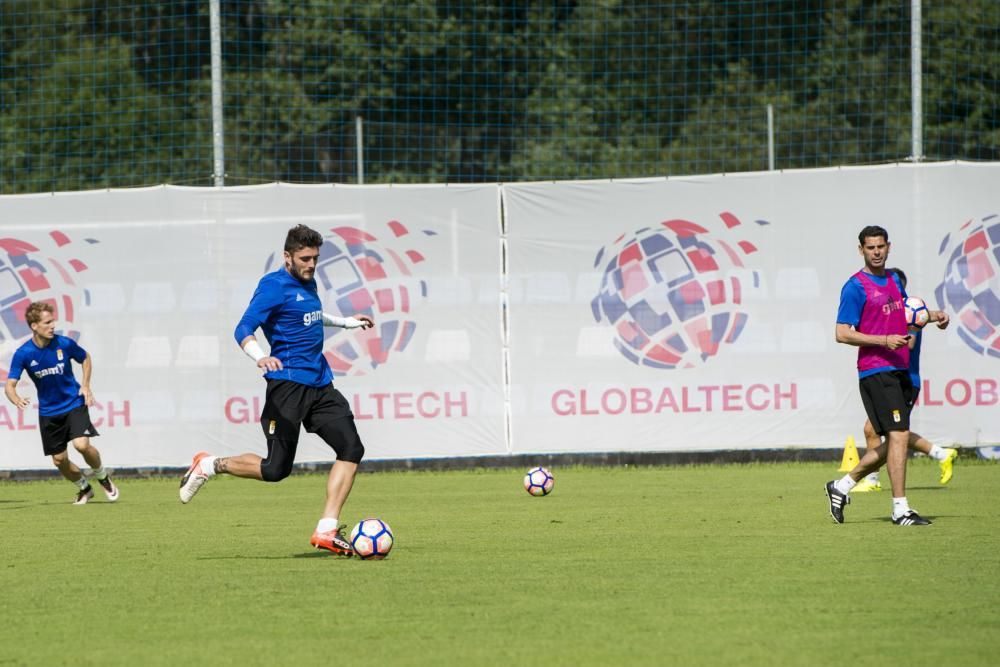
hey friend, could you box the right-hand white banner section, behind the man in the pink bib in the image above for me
[504,164,1000,453]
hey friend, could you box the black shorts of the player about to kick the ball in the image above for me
[260,380,364,451]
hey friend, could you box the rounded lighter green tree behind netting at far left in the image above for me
[0,40,205,193]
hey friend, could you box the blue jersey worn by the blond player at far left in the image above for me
[8,334,87,417]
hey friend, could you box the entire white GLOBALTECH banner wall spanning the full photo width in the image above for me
[0,164,1000,469]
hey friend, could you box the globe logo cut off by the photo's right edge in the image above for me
[934,214,1000,358]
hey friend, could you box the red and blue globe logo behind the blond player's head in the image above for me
[0,231,97,380]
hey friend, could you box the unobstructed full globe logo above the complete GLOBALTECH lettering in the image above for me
[591,213,768,369]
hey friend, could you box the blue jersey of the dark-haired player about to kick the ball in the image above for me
[233,267,333,387]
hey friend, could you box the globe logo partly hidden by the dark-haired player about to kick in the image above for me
[268,220,436,376]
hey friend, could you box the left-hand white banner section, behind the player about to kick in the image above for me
[0,184,507,469]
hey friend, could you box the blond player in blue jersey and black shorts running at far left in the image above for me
[4,301,118,505]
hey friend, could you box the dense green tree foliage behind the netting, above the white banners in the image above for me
[0,0,1000,193]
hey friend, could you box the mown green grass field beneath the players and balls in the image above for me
[0,459,1000,667]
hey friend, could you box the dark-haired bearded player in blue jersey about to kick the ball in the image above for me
[180,225,374,557]
